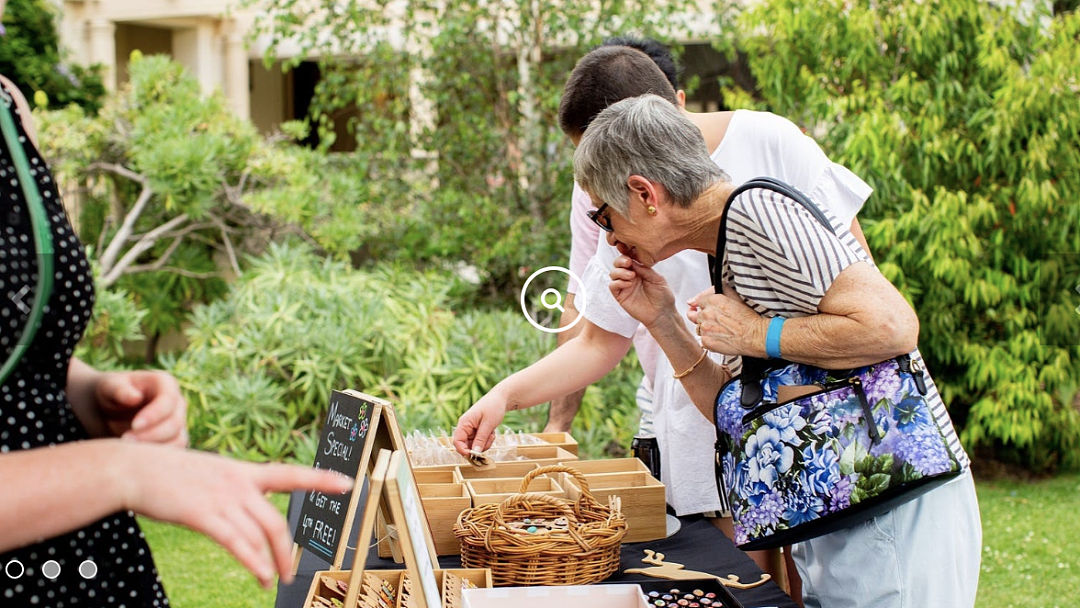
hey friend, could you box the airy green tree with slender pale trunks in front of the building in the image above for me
[248,0,689,292]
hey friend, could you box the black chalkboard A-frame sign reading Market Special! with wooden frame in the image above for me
[293,390,405,572]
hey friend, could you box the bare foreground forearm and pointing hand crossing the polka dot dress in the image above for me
[0,440,353,586]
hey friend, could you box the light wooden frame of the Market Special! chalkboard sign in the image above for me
[293,389,406,573]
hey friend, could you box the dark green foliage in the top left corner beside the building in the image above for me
[0,0,105,112]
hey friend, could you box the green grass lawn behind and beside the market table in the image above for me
[141,474,1080,608]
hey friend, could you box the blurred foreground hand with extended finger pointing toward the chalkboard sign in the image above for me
[121,443,354,587]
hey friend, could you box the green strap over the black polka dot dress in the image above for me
[0,87,53,384]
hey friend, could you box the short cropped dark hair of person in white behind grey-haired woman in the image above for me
[558,45,678,137]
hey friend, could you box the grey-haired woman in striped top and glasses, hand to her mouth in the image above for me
[573,95,982,608]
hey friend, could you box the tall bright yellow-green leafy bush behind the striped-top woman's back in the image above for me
[730,0,1080,469]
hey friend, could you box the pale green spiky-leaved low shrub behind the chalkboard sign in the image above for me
[167,244,636,462]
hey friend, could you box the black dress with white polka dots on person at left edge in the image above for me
[0,83,168,608]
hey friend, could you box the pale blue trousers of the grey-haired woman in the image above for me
[792,472,983,608]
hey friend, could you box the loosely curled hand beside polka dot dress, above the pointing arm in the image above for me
[94,371,188,447]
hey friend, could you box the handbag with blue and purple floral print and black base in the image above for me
[715,355,963,550]
